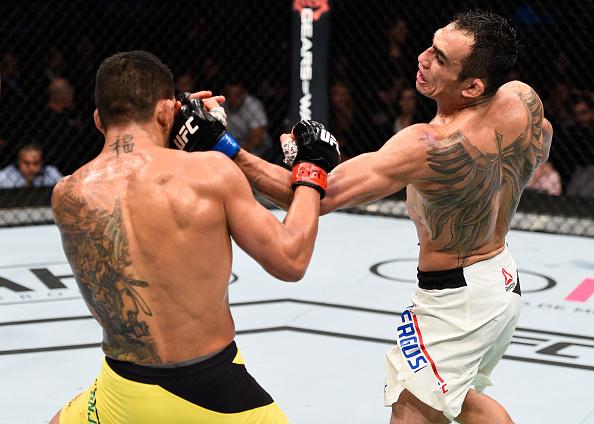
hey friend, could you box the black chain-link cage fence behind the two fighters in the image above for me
[0,0,594,236]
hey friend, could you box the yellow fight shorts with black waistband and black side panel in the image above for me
[60,342,288,424]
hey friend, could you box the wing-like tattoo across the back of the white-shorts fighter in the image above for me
[418,90,543,266]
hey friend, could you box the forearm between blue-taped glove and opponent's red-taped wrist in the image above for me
[235,150,293,210]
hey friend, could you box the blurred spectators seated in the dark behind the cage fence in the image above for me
[0,2,594,196]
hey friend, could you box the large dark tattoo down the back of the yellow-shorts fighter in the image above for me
[55,189,161,363]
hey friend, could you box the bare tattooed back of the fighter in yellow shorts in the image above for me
[52,132,234,364]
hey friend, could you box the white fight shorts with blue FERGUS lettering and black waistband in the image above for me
[384,247,521,420]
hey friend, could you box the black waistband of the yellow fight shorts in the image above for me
[105,341,237,384]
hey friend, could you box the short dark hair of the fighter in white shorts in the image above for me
[451,10,519,94]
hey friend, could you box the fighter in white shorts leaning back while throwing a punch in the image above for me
[235,11,552,424]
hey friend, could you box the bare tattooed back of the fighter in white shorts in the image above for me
[407,81,552,271]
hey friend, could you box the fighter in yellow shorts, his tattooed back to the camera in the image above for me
[51,51,340,424]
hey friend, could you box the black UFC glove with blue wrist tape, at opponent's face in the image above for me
[169,93,241,158]
